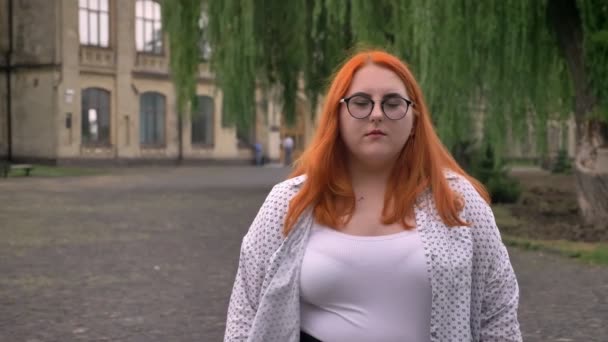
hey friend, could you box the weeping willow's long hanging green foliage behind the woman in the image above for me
[166,0,608,227]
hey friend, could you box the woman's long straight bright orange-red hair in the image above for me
[283,50,490,235]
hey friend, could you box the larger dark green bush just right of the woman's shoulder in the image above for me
[470,145,522,203]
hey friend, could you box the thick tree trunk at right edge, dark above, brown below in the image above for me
[547,0,608,229]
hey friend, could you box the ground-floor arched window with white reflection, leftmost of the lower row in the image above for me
[81,88,110,145]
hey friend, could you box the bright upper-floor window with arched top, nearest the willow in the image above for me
[135,0,163,54]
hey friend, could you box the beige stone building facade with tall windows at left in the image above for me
[0,0,298,164]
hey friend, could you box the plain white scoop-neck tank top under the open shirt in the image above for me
[300,224,431,342]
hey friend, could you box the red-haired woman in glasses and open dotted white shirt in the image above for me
[225,51,521,342]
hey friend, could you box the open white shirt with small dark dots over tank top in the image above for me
[224,171,522,342]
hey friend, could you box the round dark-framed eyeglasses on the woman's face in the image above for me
[340,95,414,120]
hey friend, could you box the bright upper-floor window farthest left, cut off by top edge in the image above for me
[78,0,110,47]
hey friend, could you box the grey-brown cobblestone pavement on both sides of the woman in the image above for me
[0,167,608,342]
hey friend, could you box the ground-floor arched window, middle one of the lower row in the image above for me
[139,92,165,146]
